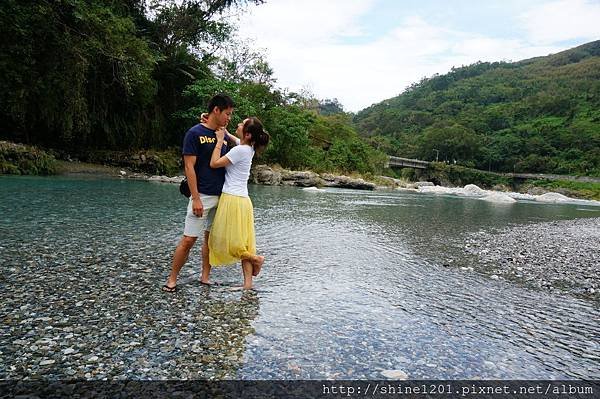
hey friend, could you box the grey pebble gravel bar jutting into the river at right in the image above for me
[462,218,600,301]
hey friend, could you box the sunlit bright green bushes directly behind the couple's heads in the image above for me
[177,79,385,174]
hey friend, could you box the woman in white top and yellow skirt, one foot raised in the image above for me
[208,118,270,290]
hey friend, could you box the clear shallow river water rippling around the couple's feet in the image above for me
[0,177,600,379]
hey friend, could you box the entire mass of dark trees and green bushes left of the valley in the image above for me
[0,0,386,174]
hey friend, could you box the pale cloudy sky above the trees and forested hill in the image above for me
[238,0,600,112]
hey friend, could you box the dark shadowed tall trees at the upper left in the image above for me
[0,0,261,150]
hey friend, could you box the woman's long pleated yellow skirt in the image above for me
[208,193,256,266]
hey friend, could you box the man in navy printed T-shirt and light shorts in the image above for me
[162,94,234,292]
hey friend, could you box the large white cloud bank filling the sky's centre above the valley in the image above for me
[240,0,600,111]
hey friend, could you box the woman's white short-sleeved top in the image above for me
[223,144,254,197]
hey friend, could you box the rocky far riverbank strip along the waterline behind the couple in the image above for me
[0,141,600,201]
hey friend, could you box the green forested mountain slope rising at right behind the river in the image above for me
[354,41,600,176]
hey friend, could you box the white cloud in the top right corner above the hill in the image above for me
[520,0,600,44]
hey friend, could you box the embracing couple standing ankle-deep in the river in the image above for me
[162,94,269,292]
